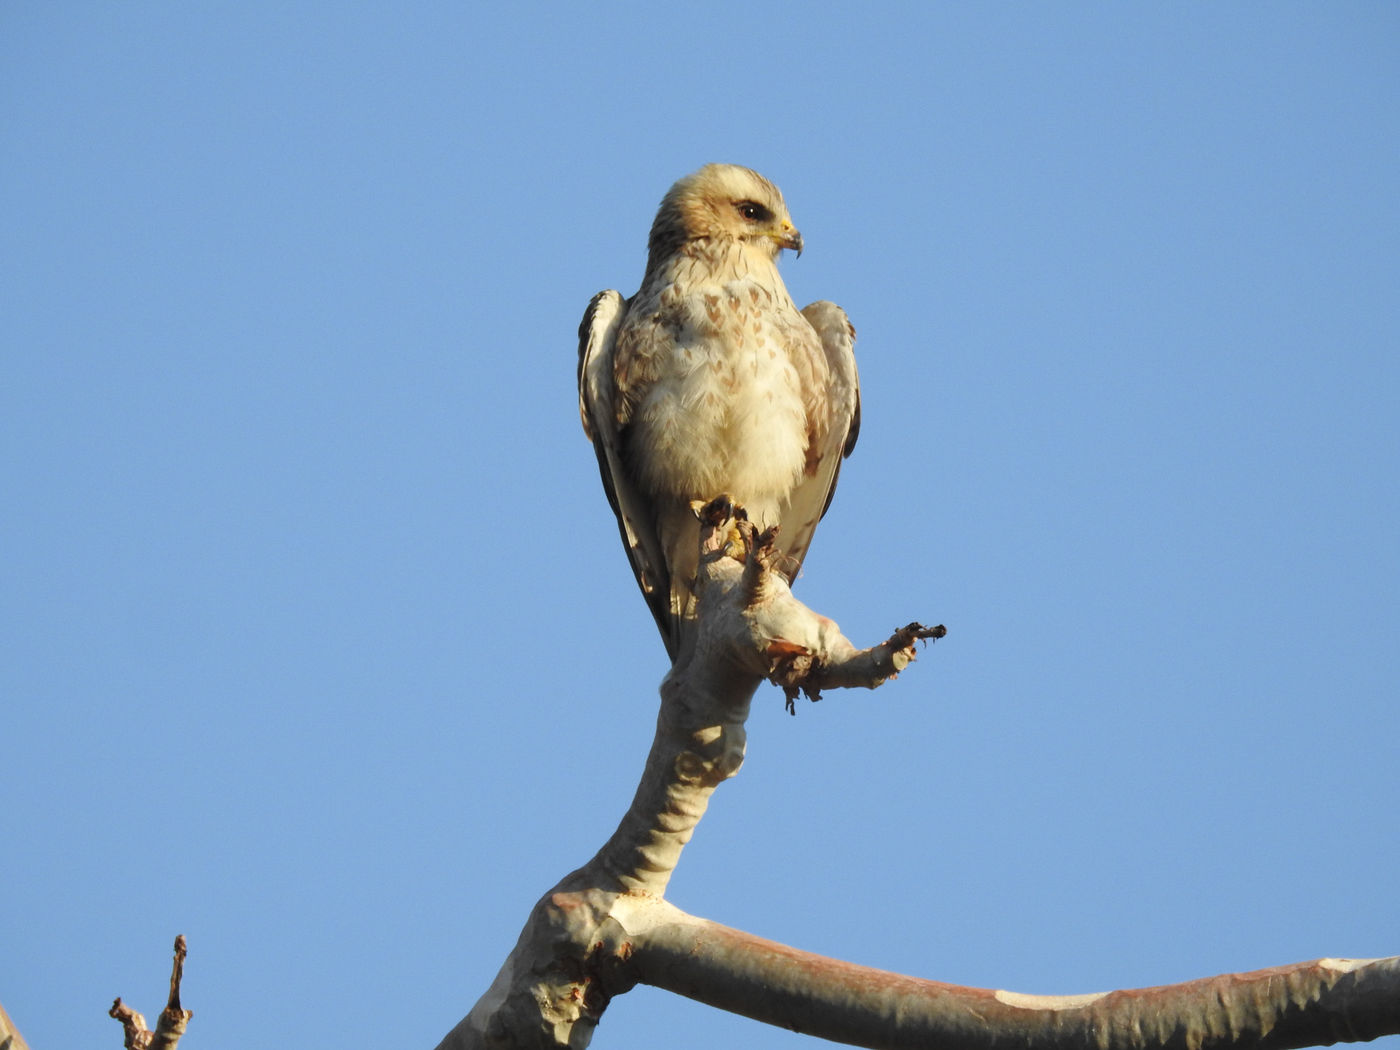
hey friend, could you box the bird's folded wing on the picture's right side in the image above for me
[778,301,861,578]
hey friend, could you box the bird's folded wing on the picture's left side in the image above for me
[578,290,676,655]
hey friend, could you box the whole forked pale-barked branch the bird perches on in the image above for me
[438,500,1400,1050]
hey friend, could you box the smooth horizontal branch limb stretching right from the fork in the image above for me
[631,911,1400,1050]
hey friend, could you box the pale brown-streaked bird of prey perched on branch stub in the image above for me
[578,164,860,661]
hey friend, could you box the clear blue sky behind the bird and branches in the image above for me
[0,0,1400,1050]
